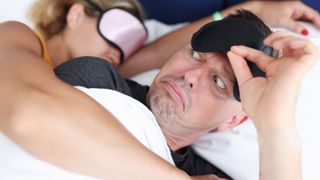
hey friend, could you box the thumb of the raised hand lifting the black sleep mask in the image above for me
[227,51,252,87]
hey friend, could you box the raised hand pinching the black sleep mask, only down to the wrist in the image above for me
[228,32,319,133]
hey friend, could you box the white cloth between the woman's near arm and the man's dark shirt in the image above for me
[76,87,174,164]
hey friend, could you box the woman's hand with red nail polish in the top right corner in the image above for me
[248,1,320,35]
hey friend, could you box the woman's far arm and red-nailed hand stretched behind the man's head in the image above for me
[118,1,320,78]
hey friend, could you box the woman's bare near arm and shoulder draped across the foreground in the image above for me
[0,22,189,179]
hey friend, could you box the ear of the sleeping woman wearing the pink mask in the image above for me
[67,3,85,29]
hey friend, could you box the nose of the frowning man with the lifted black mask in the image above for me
[184,65,208,89]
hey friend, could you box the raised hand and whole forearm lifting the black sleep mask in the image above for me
[228,32,319,180]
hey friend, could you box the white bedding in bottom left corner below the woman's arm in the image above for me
[0,133,96,180]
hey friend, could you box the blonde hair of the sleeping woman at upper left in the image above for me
[28,0,144,39]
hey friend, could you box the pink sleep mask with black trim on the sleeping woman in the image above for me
[86,0,148,62]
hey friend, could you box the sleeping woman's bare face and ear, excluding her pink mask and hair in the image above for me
[65,2,140,67]
